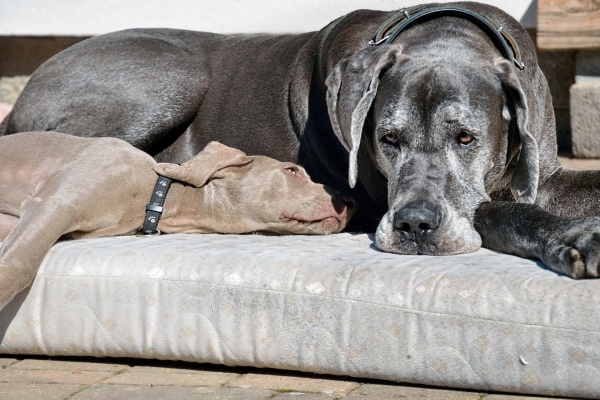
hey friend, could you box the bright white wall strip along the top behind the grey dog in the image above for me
[0,0,536,36]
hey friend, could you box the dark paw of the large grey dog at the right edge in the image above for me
[543,218,600,279]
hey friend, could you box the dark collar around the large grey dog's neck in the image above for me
[368,6,525,71]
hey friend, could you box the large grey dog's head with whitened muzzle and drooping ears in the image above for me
[326,44,538,255]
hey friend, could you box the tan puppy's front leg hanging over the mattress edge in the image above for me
[0,198,75,310]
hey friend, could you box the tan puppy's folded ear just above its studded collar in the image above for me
[152,142,252,187]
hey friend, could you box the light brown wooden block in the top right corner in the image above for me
[537,0,600,50]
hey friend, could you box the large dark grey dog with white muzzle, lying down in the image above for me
[0,2,600,278]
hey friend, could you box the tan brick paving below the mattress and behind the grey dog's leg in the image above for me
[0,155,600,400]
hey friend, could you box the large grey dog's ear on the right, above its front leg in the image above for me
[496,58,540,203]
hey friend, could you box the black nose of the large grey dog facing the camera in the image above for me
[394,200,441,237]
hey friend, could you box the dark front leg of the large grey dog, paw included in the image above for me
[475,201,600,279]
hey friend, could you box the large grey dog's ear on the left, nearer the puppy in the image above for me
[325,45,401,187]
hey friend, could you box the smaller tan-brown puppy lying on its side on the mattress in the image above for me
[0,132,354,309]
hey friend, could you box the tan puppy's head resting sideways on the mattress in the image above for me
[154,142,355,235]
